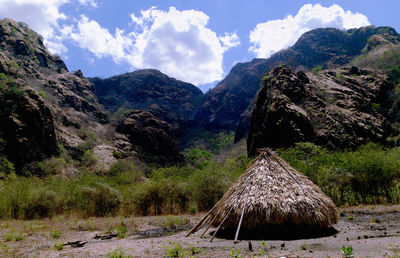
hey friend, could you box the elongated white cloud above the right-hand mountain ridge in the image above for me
[249,4,370,58]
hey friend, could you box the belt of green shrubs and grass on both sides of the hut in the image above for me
[0,143,400,219]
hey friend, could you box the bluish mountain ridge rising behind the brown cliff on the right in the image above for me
[195,26,400,136]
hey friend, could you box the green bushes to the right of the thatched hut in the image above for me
[279,143,400,205]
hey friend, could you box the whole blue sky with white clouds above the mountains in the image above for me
[0,0,400,90]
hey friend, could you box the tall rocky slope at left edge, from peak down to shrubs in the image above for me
[0,19,107,171]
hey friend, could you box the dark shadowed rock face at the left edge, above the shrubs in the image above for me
[0,84,58,170]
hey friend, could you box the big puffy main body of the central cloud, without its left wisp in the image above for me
[130,7,238,84]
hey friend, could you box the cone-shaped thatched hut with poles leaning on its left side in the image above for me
[187,149,339,240]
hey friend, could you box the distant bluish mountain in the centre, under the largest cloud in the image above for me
[90,69,203,129]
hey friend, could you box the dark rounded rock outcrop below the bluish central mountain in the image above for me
[117,110,184,165]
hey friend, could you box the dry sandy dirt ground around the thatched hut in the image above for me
[0,205,400,258]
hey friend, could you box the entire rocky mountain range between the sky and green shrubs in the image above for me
[0,15,400,171]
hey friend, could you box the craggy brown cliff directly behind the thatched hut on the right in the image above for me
[247,66,398,156]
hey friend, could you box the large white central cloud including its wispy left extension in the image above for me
[70,7,240,85]
